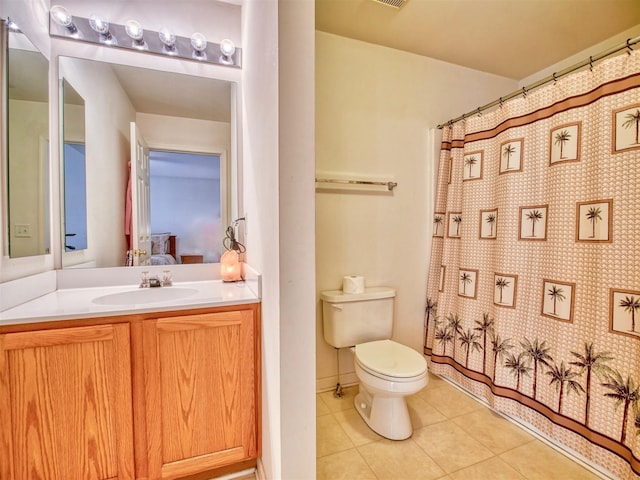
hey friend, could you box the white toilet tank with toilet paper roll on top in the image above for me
[320,287,396,348]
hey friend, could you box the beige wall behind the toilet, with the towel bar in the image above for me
[316,32,517,390]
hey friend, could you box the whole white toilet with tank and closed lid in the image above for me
[320,287,429,440]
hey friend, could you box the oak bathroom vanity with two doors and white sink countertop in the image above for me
[0,280,261,479]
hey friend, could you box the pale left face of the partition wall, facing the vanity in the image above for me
[240,2,283,479]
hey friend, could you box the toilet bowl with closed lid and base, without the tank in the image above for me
[353,340,428,440]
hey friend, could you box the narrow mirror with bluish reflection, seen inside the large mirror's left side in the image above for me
[61,80,87,252]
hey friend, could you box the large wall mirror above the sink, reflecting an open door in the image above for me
[59,57,234,268]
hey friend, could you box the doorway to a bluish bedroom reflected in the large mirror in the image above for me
[149,149,223,263]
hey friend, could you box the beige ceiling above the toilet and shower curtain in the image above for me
[315,0,640,80]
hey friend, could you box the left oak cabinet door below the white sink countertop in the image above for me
[0,324,133,480]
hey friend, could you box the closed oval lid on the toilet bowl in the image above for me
[355,340,427,378]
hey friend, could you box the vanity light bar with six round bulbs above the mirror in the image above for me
[49,5,242,68]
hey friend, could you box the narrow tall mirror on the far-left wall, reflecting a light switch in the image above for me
[7,26,50,258]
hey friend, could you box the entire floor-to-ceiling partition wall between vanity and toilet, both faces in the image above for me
[241,0,316,480]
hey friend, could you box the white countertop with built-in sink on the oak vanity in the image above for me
[0,280,260,326]
